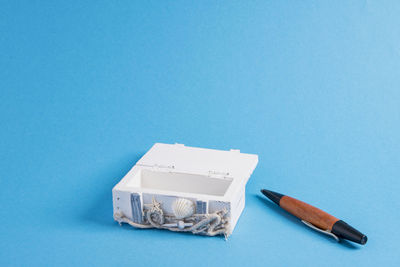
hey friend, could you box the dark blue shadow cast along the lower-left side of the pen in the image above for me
[253,194,360,249]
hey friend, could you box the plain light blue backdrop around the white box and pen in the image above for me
[0,1,400,267]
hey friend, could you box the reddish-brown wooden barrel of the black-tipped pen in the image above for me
[279,196,339,230]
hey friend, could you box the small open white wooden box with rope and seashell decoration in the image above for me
[112,143,258,237]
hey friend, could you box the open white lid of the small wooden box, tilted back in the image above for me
[136,143,258,181]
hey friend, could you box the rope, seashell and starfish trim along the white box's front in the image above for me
[114,198,229,237]
